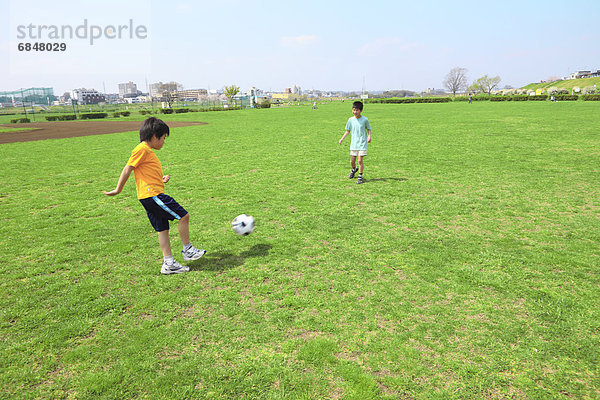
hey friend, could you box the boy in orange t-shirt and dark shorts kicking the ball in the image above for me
[104,117,206,275]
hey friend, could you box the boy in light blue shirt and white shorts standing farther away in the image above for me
[340,101,371,184]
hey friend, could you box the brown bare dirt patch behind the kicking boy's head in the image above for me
[0,121,206,144]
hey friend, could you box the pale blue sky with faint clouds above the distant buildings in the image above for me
[0,0,600,95]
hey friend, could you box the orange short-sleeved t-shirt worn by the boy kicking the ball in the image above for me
[127,142,165,199]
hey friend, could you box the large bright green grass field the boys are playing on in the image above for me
[0,102,600,399]
